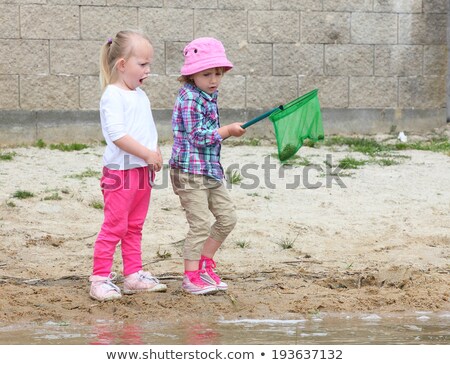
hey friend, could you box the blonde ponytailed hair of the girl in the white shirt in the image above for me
[100,30,151,92]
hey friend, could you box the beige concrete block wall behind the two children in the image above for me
[0,0,448,144]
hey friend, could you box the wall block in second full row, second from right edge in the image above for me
[375,45,423,76]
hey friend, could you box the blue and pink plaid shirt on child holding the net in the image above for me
[169,83,224,181]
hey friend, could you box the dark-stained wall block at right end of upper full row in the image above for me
[398,14,447,44]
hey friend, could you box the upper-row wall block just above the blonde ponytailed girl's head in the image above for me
[80,6,138,42]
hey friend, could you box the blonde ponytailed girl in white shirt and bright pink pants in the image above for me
[89,31,167,301]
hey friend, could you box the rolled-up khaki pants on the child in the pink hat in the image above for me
[170,169,236,260]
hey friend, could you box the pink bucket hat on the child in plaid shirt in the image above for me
[181,37,233,76]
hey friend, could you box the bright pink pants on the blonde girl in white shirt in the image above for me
[93,167,153,276]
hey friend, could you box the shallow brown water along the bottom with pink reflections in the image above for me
[0,312,450,345]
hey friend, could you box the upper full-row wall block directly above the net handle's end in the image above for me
[248,10,300,43]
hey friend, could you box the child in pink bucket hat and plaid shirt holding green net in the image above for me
[169,38,245,294]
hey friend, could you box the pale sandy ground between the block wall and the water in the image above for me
[0,129,450,323]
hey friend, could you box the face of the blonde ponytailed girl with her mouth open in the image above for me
[117,38,153,90]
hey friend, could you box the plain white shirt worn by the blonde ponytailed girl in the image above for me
[100,85,158,170]
